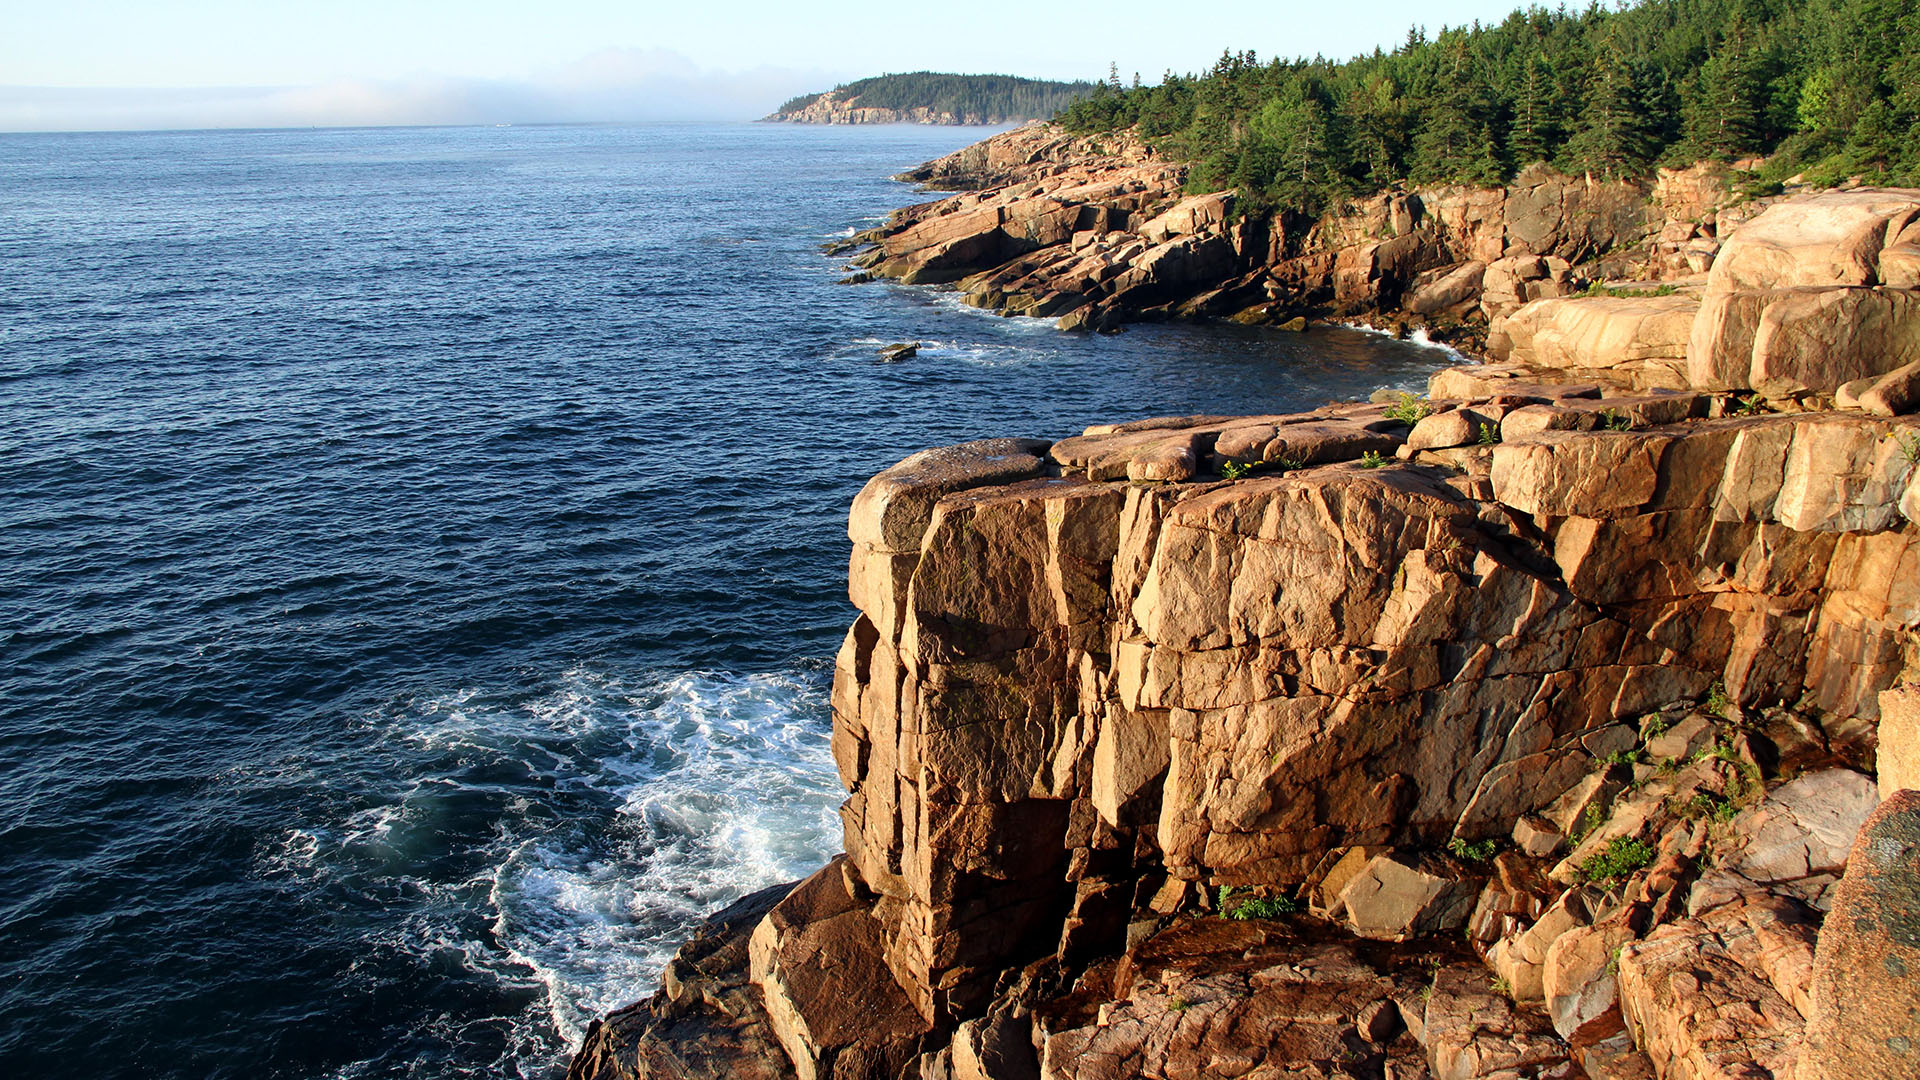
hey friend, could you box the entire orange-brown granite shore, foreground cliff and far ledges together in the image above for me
[568,136,1920,1080]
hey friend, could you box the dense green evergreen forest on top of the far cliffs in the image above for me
[1058,0,1920,213]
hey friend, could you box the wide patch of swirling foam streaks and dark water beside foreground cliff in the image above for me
[259,671,841,1076]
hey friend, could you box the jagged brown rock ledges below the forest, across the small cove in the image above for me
[847,125,1905,351]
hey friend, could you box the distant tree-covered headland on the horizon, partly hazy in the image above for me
[766,71,1096,123]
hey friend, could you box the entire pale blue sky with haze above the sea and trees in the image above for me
[0,0,1519,131]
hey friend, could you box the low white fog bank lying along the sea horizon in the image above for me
[0,48,843,131]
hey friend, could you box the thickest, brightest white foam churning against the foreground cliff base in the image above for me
[492,675,841,1043]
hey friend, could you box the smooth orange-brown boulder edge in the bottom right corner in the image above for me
[1799,792,1920,1080]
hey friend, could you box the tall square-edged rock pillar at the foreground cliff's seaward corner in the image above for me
[833,440,1125,1022]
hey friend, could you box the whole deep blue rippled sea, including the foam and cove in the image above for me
[0,125,1450,1078]
